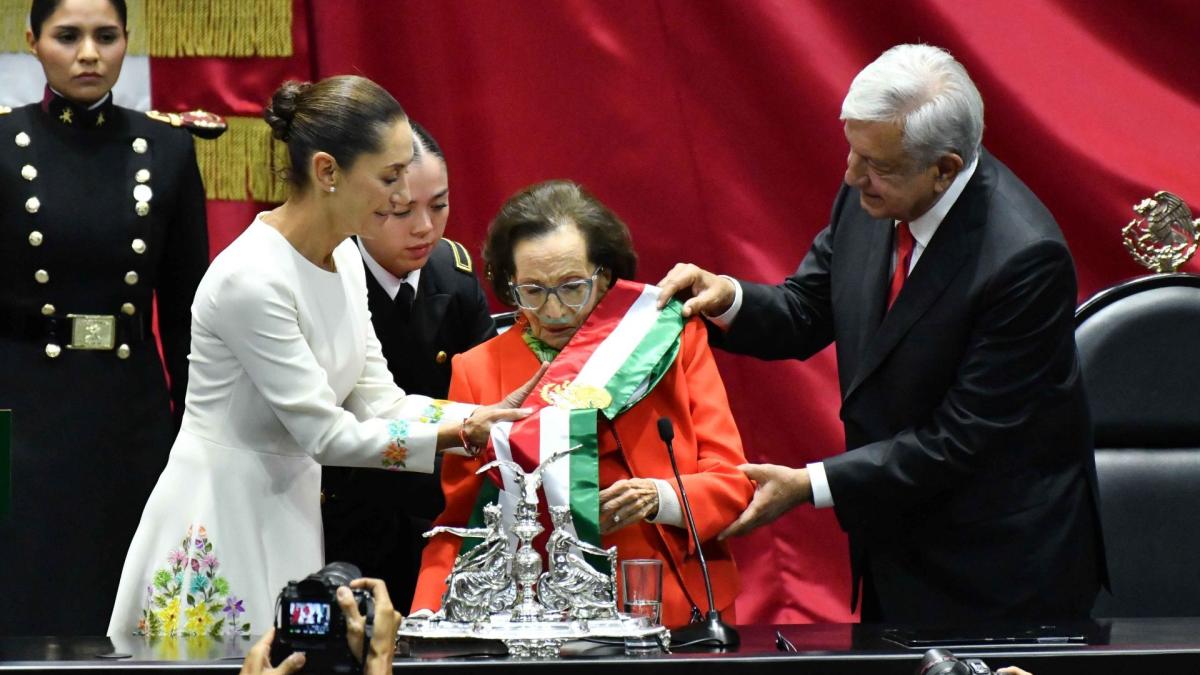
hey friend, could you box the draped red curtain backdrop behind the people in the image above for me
[147,0,1200,622]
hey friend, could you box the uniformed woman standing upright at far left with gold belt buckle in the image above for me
[0,0,209,635]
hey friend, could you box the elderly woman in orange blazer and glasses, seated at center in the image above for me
[413,181,754,627]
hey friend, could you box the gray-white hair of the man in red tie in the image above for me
[841,44,983,167]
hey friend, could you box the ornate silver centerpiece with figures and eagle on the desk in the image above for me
[397,448,671,658]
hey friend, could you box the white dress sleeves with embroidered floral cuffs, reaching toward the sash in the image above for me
[209,265,470,473]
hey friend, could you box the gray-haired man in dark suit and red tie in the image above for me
[661,44,1106,625]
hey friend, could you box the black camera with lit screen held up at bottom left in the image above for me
[271,562,374,673]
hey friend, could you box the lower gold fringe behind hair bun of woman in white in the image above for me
[196,117,288,203]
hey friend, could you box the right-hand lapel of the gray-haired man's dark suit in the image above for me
[842,170,984,400]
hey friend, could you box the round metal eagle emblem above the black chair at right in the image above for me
[1121,191,1200,273]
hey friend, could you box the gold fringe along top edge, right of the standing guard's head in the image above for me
[144,0,292,56]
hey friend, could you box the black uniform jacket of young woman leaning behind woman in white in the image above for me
[322,239,496,607]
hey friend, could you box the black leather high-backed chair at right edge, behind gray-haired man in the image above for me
[1075,274,1200,617]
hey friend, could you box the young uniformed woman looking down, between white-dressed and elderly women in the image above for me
[322,121,496,608]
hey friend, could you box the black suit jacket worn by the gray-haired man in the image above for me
[710,151,1105,623]
